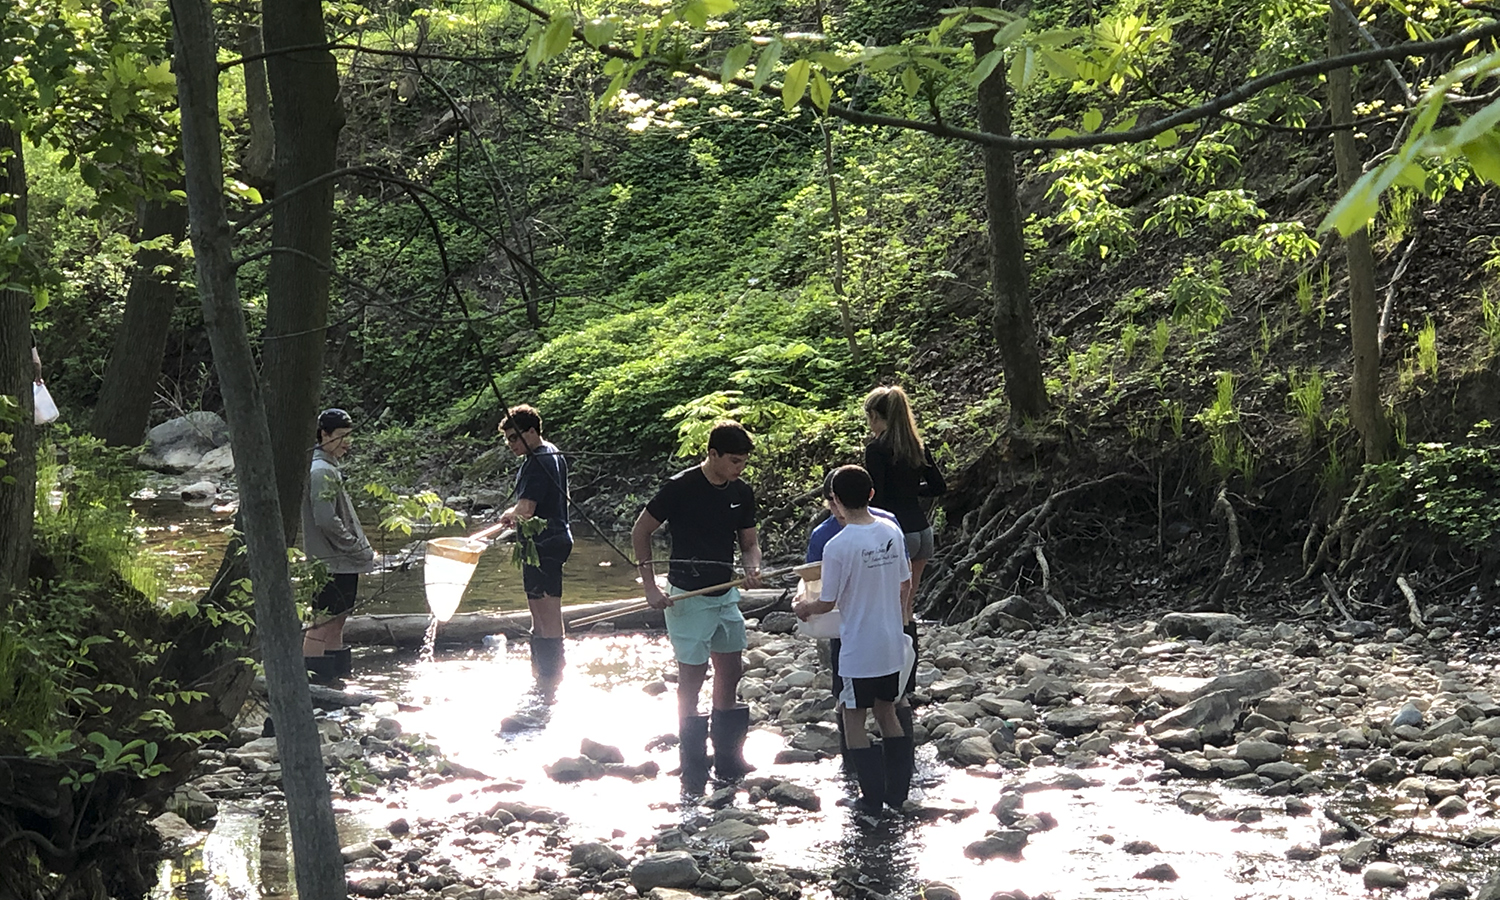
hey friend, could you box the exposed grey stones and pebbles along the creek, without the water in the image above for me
[156,603,1500,900]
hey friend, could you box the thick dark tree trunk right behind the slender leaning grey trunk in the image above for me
[264,0,344,545]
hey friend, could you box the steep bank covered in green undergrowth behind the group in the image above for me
[20,0,1500,627]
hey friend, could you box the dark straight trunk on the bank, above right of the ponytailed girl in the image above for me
[974,12,1047,422]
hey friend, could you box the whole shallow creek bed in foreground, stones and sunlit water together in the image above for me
[149,608,1500,900]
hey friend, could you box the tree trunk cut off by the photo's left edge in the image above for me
[0,122,36,597]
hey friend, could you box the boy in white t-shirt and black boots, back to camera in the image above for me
[795,465,915,812]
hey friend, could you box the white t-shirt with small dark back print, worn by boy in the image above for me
[824,519,912,678]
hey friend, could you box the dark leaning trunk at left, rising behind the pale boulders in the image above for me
[89,201,188,447]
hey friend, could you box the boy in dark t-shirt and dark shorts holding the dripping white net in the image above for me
[500,405,573,678]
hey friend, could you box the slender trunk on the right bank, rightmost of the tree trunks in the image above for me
[1328,5,1391,462]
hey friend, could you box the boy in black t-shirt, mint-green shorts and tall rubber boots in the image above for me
[630,423,761,794]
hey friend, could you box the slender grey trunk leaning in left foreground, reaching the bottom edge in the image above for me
[173,0,348,900]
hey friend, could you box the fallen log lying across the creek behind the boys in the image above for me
[344,588,792,647]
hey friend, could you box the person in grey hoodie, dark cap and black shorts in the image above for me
[302,410,375,678]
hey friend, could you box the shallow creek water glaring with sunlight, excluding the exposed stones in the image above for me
[143,506,1482,900]
